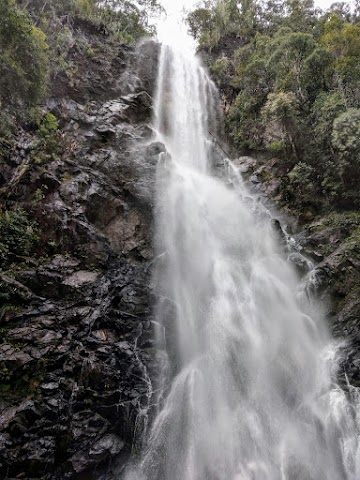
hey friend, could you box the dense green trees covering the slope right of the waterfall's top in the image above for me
[188,0,360,211]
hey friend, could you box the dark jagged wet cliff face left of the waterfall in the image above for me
[0,20,163,480]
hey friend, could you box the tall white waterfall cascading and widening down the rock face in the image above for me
[125,37,360,480]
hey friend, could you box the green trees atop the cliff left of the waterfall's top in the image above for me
[0,0,160,134]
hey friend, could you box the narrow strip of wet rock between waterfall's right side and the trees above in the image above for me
[234,156,360,389]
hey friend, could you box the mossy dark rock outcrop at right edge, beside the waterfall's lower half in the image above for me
[292,218,360,388]
